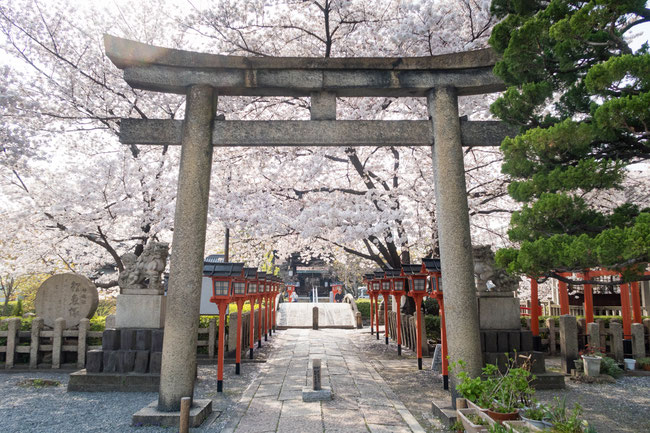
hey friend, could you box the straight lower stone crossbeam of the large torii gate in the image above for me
[120,119,517,148]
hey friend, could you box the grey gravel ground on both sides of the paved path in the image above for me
[0,327,650,433]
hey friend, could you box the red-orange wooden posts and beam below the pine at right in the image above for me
[530,269,650,338]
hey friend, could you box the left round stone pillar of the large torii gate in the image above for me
[158,85,217,412]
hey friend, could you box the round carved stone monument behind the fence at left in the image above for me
[34,274,99,328]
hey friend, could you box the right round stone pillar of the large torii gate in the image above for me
[427,87,483,390]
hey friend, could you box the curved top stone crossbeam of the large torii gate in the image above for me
[104,35,504,97]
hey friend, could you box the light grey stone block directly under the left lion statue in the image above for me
[115,294,166,328]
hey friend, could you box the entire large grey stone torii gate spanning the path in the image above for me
[104,35,516,412]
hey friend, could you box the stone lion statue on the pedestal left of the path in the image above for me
[117,242,169,294]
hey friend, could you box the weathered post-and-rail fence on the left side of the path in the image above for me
[0,308,266,369]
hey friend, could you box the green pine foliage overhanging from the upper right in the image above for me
[490,0,650,279]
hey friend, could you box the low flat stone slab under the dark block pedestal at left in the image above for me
[68,369,160,392]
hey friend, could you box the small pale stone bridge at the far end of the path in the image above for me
[276,302,356,329]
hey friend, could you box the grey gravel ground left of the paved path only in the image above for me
[0,338,273,433]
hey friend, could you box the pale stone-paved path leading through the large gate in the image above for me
[224,329,424,433]
